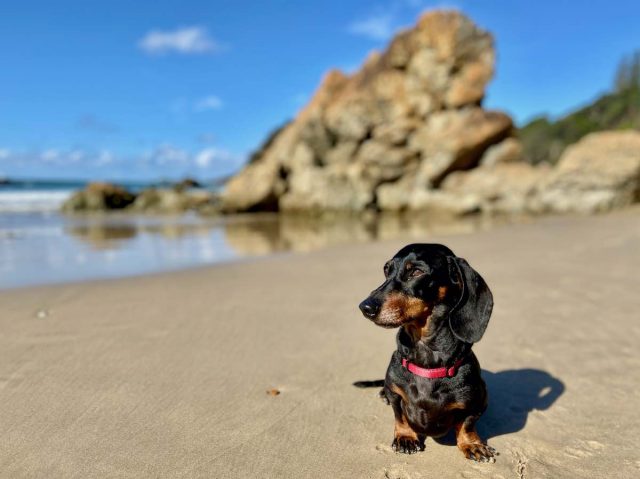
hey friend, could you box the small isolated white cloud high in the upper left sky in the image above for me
[138,27,220,54]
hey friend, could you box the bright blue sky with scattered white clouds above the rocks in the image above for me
[0,0,640,179]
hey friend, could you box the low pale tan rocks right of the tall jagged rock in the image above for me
[429,131,640,215]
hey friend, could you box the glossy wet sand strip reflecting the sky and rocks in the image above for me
[0,212,533,289]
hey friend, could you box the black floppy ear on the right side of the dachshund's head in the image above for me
[447,256,493,343]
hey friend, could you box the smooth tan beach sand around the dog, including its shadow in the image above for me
[0,209,640,478]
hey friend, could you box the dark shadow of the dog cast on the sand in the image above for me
[438,369,565,444]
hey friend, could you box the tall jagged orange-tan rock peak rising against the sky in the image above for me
[222,11,517,212]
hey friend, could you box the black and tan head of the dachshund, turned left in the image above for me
[360,244,493,343]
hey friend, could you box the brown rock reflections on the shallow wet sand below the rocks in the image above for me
[65,214,528,256]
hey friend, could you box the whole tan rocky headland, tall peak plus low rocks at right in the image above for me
[221,11,640,214]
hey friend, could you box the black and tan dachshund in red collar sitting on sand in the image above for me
[356,244,496,461]
